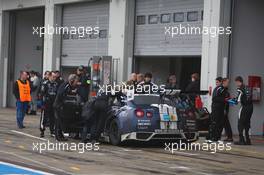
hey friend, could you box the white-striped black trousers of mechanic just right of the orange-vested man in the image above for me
[40,103,55,134]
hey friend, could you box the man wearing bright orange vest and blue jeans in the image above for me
[13,71,31,129]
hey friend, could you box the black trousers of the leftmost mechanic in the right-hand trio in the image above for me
[209,105,224,141]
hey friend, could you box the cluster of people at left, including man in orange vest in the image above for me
[13,66,90,140]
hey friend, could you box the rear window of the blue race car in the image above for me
[132,94,160,105]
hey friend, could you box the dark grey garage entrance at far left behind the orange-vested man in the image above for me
[6,8,44,107]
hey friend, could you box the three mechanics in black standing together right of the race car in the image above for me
[209,76,253,145]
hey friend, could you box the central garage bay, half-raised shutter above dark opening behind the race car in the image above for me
[134,0,203,88]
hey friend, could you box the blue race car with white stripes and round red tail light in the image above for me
[104,91,198,145]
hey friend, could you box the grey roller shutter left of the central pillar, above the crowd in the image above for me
[61,0,109,67]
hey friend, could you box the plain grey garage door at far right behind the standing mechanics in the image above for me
[229,0,264,135]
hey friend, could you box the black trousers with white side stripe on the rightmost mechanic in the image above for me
[238,105,253,139]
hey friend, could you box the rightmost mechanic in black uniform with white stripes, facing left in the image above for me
[234,76,253,145]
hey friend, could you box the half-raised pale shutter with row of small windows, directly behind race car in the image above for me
[134,0,203,56]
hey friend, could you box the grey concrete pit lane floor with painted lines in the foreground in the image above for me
[0,109,264,175]
